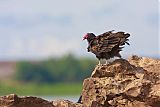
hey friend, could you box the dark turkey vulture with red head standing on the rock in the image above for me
[83,31,130,64]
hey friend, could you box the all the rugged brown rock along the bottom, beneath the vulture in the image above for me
[0,56,160,107]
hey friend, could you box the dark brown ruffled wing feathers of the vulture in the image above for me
[91,31,130,53]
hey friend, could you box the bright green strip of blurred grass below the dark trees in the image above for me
[0,82,82,96]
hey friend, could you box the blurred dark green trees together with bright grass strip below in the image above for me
[0,54,96,96]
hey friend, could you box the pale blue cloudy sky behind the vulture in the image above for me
[0,0,160,60]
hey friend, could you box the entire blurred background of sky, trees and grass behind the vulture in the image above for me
[0,0,160,100]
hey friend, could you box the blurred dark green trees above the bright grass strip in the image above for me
[14,54,95,84]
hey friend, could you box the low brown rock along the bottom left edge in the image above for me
[0,94,82,107]
